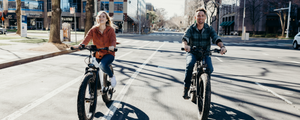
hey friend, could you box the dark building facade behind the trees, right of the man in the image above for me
[214,0,300,36]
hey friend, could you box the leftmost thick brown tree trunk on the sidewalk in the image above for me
[49,0,62,44]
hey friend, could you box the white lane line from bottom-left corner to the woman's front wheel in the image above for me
[2,75,83,120]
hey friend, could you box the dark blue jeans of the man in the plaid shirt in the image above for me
[184,52,214,88]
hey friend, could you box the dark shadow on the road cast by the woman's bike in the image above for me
[95,102,149,120]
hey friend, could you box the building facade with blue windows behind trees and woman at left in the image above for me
[0,0,146,32]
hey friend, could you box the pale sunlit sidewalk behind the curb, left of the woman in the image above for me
[0,32,142,69]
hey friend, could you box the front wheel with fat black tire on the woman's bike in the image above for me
[77,73,97,120]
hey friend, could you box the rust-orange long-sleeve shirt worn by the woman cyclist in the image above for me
[80,26,117,59]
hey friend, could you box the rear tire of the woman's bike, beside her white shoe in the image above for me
[102,65,114,104]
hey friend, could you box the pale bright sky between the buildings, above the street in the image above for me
[145,0,185,18]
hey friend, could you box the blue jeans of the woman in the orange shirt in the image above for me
[97,54,115,77]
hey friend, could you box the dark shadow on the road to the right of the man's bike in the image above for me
[208,103,255,120]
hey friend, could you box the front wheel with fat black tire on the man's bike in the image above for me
[197,73,211,120]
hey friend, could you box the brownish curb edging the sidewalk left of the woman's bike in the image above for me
[0,50,76,69]
